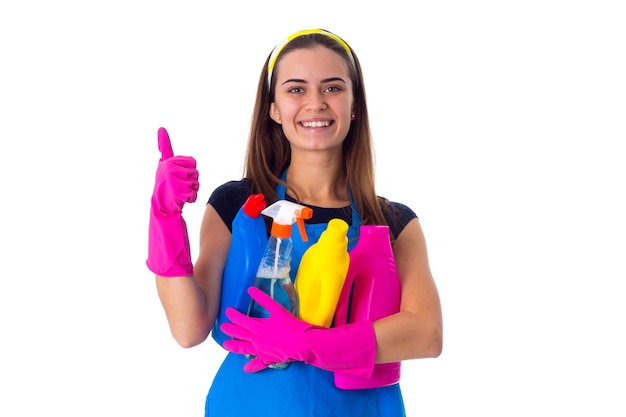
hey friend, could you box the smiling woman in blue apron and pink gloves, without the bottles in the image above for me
[147,29,443,417]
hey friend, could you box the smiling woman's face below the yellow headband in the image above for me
[270,46,354,152]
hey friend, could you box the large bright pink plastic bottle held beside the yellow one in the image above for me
[334,226,400,389]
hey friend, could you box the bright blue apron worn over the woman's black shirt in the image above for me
[205,173,406,417]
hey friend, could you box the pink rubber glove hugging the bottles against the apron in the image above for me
[221,287,376,378]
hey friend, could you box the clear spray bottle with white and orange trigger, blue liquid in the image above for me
[248,200,313,369]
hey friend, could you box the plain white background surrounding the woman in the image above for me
[0,0,626,417]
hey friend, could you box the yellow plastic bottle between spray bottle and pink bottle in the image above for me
[295,219,350,327]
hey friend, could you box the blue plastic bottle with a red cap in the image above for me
[211,194,267,346]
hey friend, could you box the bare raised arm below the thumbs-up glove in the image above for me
[156,204,231,348]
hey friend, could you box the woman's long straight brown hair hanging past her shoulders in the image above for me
[244,33,388,225]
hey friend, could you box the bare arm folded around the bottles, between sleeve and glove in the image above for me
[374,219,443,363]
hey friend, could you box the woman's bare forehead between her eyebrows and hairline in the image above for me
[276,46,350,82]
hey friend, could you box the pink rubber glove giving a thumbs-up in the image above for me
[146,128,200,277]
